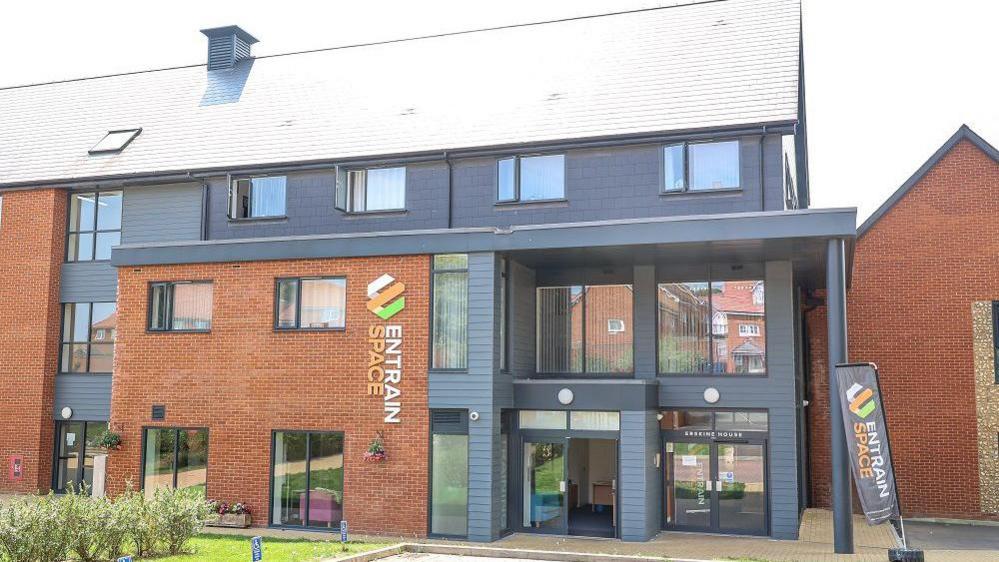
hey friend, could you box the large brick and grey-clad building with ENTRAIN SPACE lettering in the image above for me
[0,0,855,541]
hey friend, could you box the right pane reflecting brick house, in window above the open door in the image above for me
[585,285,634,373]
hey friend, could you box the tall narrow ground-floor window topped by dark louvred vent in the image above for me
[430,410,468,537]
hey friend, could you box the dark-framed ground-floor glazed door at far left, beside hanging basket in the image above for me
[52,421,108,493]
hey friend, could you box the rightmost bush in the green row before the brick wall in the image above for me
[151,488,212,554]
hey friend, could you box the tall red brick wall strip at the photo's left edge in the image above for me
[0,189,66,492]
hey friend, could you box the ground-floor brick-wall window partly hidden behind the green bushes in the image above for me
[142,427,208,497]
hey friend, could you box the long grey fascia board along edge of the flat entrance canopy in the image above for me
[111,208,856,267]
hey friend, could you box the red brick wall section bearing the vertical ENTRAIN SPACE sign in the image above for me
[109,256,430,535]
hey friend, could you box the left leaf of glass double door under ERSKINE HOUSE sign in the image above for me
[667,443,711,528]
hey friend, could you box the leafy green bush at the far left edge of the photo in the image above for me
[0,494,69,562]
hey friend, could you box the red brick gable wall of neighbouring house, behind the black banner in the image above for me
[808,141,999,517]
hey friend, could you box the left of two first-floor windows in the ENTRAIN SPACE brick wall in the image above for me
[149,281,212,332]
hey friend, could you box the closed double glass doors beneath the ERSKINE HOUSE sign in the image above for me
[664,442,767,534]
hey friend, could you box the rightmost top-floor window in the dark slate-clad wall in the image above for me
[663,140,739,193]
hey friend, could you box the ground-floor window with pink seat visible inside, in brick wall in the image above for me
[271,431,343,528]
